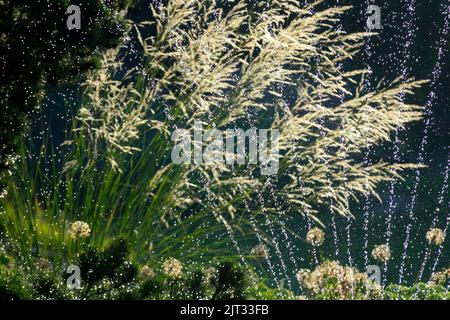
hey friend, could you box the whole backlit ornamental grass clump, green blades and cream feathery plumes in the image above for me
[2,0,423,259]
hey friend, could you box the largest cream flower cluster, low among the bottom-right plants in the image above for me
[296,261,381,299]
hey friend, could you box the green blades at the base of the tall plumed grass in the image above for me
[0,132,241,267]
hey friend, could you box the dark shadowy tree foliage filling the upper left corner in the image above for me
[0,0,131,192]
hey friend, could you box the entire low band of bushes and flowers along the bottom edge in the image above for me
[0,239,450,300]
